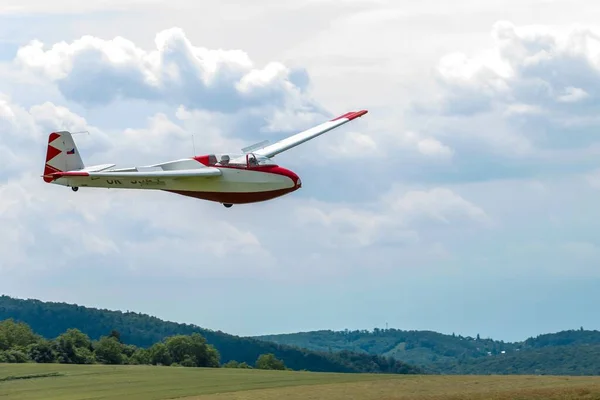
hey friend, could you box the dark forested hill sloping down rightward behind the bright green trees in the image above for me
[0,296,420,374]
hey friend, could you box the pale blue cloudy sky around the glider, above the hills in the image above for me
[0,0,600,341]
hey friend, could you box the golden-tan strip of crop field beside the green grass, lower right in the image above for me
[184,376,600,400]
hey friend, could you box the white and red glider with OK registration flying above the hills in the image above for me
[43,110,368,208]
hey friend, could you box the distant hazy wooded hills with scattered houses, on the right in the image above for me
[257,329,600,375]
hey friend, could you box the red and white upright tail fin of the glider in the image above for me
[44,131,85,182]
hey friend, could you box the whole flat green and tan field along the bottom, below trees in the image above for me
[0,364,600,400]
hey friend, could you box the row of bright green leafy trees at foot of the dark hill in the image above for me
[0,319,287,370]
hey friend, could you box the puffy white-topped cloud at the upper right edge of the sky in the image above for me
[437,21,600,120]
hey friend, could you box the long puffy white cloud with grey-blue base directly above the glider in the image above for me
[15,28,320,112]
